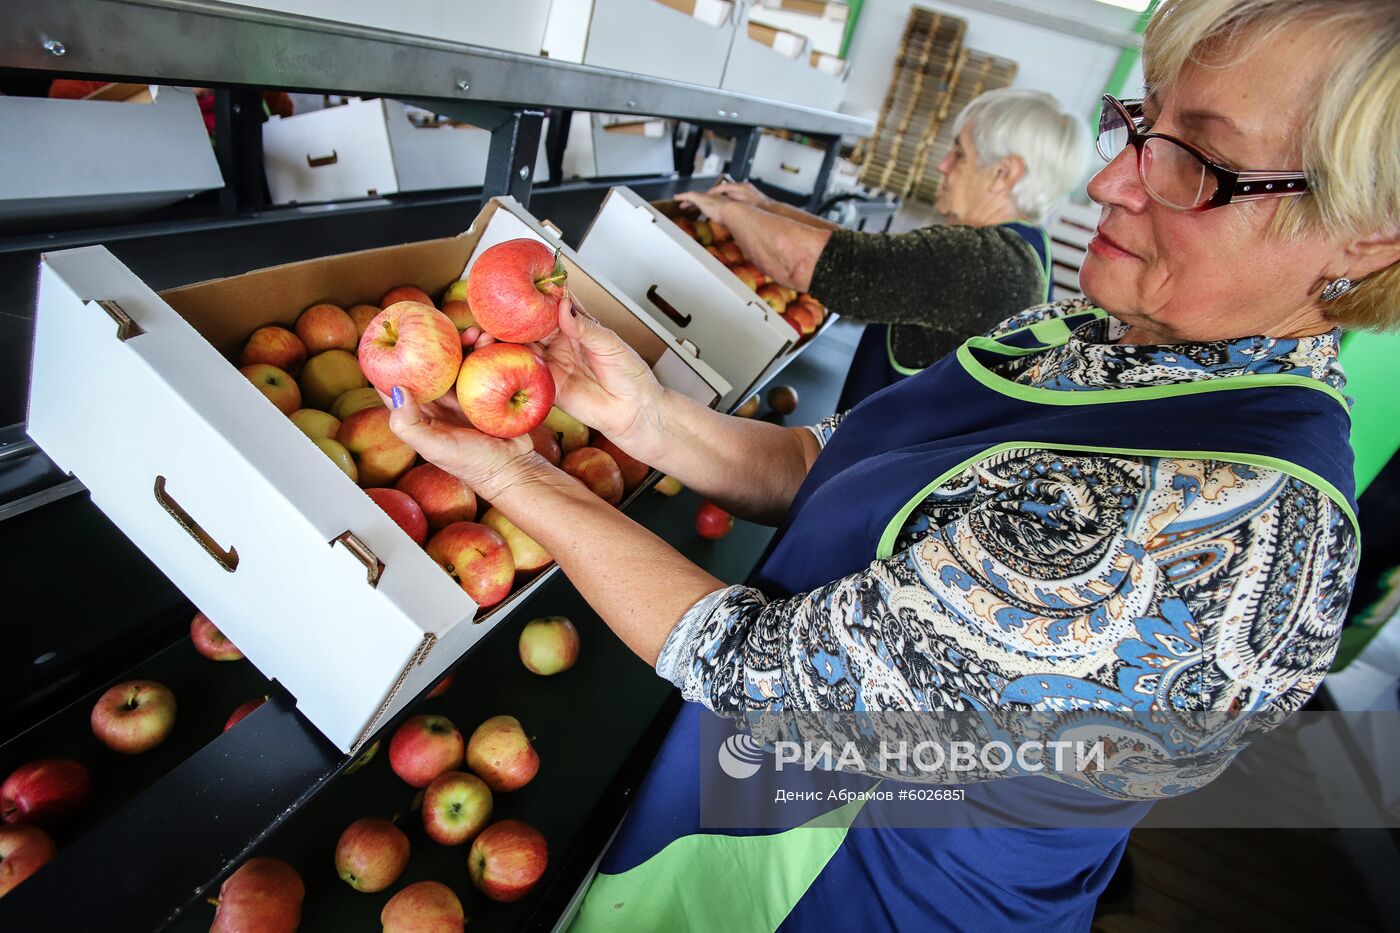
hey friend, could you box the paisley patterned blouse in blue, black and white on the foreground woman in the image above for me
[657,301,1358,739]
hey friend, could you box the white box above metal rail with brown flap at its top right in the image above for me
[545,0,735,87]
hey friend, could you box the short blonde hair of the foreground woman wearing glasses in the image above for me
[1142,0,1400,329]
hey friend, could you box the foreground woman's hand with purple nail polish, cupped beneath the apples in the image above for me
[385,388,543,502]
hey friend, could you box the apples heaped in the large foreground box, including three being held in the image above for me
[238,237,651,608]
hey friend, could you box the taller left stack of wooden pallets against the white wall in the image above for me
[857,7,967,195]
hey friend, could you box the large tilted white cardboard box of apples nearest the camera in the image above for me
[28,199,729,751]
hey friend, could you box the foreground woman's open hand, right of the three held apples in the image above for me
[543,296,665,459]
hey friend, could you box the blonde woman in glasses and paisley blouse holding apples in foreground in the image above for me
[392,0,1400,930]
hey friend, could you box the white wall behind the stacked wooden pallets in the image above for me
[841,0,1141,120]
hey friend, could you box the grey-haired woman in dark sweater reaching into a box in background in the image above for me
[679,88,1085,412]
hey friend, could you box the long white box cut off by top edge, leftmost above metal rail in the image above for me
[221,0,549,55]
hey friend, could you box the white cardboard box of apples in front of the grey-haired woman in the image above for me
[578,188,797,409]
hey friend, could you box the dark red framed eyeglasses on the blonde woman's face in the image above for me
[1098,94,1308,212]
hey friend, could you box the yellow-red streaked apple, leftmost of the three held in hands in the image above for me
[358,301,462,402]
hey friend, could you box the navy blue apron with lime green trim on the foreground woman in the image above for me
[574,311,1355,933]
